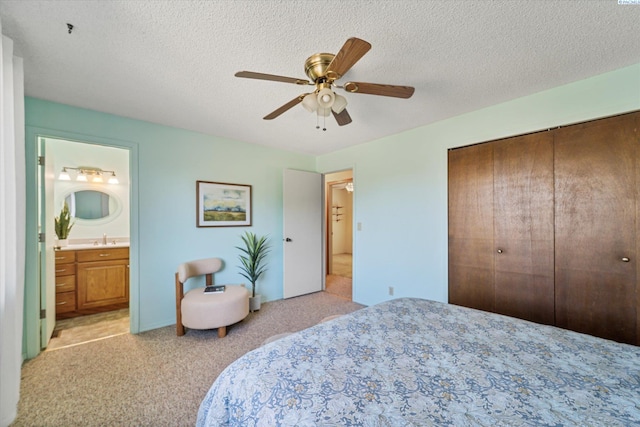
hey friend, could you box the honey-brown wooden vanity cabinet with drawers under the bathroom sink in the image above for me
[56,248,129,319]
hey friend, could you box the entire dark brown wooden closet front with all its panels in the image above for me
[449,113,640,344]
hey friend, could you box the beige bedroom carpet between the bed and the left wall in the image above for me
[13,292,362,426]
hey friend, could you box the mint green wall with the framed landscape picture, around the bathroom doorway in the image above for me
[25,98,315,354]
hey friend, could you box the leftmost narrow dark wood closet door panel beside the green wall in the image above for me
[449,144,495,311]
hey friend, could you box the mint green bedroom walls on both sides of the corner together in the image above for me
[25,64,640,357]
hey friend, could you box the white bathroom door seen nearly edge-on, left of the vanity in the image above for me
[38,138,56,348]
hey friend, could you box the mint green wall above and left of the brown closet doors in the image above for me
[316,64,640,305]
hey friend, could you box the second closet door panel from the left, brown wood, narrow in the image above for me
[491,132,555,325]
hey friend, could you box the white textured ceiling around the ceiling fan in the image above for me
[0,0,640,154]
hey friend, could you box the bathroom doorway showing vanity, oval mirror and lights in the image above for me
[39,137,131,350]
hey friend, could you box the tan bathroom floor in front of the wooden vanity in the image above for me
[47,308,129,351]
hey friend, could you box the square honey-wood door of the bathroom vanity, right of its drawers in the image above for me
[77,259,129,310]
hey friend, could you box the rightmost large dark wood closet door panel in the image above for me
[555,114,638,343]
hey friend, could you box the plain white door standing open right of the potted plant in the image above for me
[283,169,322,298]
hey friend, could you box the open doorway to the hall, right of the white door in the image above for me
[325,170,354,300]
